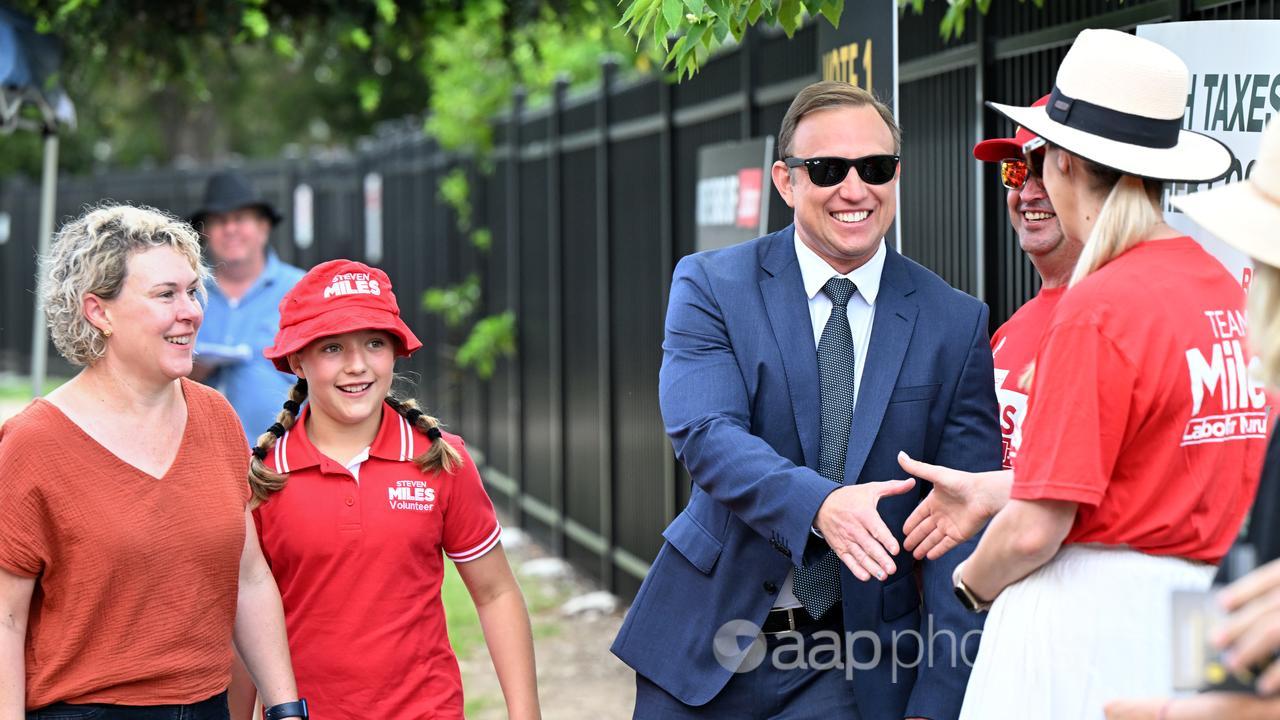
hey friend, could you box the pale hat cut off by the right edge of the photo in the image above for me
[1169,118,1280,268]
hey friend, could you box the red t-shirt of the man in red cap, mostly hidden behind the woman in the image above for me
[991,287,1066,470]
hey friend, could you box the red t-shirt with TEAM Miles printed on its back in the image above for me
[1012,237,1268,562]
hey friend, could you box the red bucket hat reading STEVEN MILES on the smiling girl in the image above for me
[262,260,422,373]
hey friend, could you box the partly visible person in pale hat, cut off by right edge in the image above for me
[1107,120,1280,720]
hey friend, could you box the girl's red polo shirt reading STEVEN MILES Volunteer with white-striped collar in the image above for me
[253,405,502,720]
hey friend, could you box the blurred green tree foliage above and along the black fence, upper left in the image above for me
[0,0,650,387]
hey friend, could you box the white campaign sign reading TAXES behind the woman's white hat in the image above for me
[1138,20,1280,287]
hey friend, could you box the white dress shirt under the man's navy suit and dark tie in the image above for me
[773,233,886,609]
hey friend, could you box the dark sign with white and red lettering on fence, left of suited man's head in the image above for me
[695,135,773,250]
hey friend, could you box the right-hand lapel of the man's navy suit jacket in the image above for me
[844,250,919,482]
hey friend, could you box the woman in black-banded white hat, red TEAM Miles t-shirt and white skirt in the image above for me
[890,29,1267,720]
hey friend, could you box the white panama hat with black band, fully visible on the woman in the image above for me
[987,29,1231,182]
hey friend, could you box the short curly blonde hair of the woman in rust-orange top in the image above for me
[40,205,209,365]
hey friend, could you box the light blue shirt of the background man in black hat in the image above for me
[196,251,305,445]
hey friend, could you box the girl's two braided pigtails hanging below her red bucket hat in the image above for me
[248,378,462,505]
